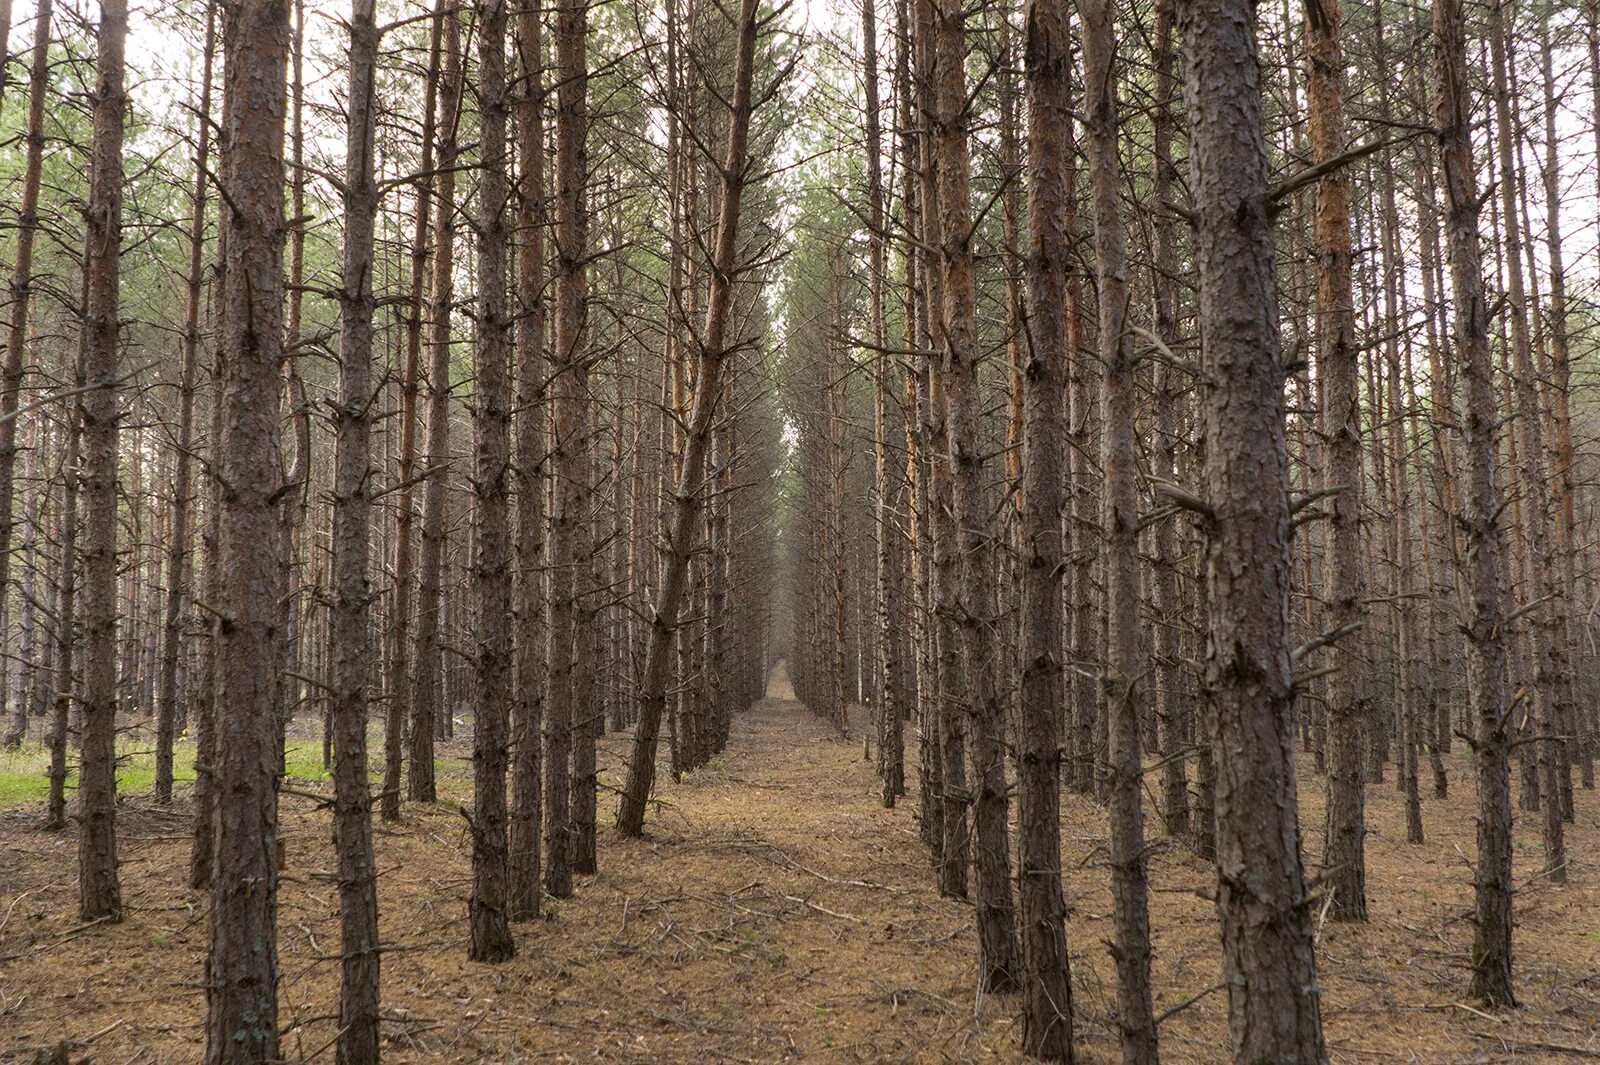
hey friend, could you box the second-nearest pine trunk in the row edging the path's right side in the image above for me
[931,0,1022,993]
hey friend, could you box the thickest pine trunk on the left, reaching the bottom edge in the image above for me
[206,2,290,1065]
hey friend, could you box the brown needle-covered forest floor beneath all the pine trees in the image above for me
[0,673,1600,1065]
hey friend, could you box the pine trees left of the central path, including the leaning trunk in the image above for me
[0,0,794,1062]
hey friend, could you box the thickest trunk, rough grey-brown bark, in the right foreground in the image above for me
[1178,0,1326,1063]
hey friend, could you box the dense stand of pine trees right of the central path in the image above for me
[774,0,1600,1062]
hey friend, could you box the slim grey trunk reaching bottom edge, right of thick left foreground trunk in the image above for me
[328,0,382,1042]
